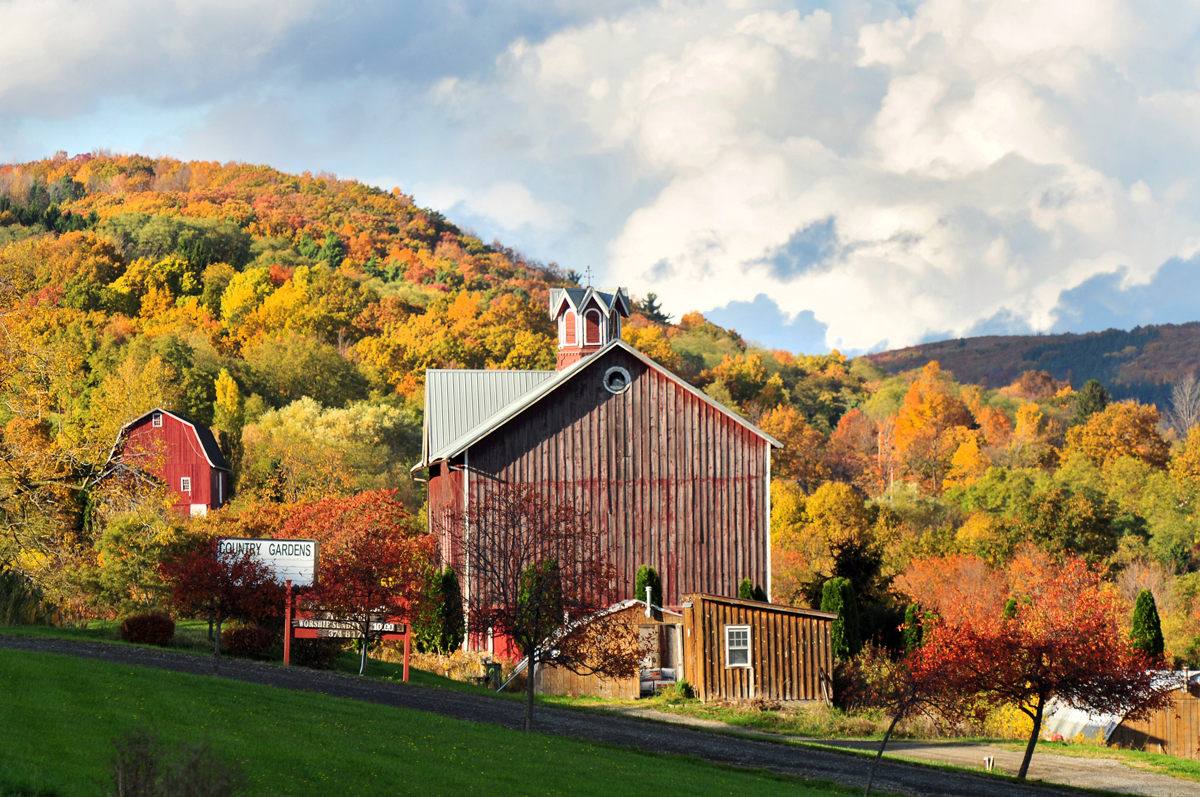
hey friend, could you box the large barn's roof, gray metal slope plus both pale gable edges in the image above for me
[413,338,784,471]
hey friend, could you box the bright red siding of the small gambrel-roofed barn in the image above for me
[124,413,229,513]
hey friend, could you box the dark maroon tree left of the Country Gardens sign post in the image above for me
[161,537,283,667]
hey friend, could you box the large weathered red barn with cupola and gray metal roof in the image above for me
[414,288,780,605]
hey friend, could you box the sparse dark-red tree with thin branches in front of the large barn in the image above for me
[451,484,641,732]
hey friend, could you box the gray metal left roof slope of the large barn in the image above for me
[421,368,558,465]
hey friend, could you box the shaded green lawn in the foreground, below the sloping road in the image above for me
[0,651,883,797]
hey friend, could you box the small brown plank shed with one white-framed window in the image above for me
[683,594,838,701]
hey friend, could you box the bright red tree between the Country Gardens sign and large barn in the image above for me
[280,490,437,675]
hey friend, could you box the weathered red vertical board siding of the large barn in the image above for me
[430,349,770,605]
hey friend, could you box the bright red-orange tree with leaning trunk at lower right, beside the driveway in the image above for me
[922,558,1166,779]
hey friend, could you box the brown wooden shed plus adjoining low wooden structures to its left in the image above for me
[535,594,836,702]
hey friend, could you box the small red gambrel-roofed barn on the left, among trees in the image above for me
[110,408,229,515]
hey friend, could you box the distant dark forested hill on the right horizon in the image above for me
[868,323,1200,407]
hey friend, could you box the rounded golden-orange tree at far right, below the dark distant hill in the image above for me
[1063,401,1170,468]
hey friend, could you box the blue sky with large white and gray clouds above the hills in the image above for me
[0,0,1200,353]
